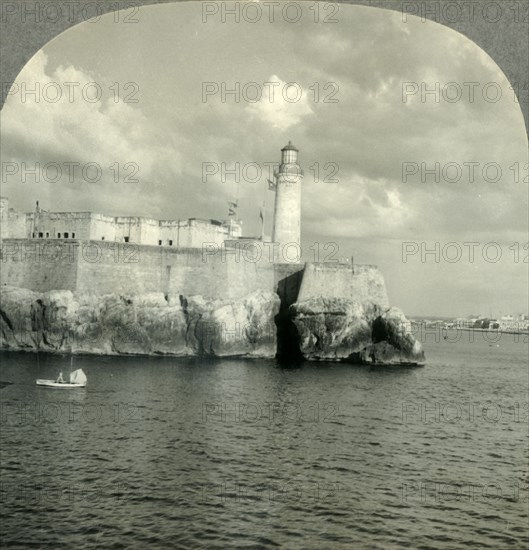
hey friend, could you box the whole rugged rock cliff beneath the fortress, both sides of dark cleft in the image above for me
[0,286,424,364]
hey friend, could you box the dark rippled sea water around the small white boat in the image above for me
[0,334,529,550]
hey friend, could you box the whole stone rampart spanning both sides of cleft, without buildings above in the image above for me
[0,238,388,306]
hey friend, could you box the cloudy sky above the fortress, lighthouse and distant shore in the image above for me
[1,3,529,316]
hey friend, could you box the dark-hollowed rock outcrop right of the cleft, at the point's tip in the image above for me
[290,298,424,364]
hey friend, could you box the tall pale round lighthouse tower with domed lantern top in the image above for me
[272,141,303,263]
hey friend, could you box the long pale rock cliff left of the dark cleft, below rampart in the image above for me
[0,286,279,357]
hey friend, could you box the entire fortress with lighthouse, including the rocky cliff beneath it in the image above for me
[0,142,422,360]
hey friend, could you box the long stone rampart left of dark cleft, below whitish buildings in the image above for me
[2,239,274,299]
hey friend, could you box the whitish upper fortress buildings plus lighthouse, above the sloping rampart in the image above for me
[0,142,303,263]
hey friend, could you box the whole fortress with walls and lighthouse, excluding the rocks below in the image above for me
[1,142,387,305]
